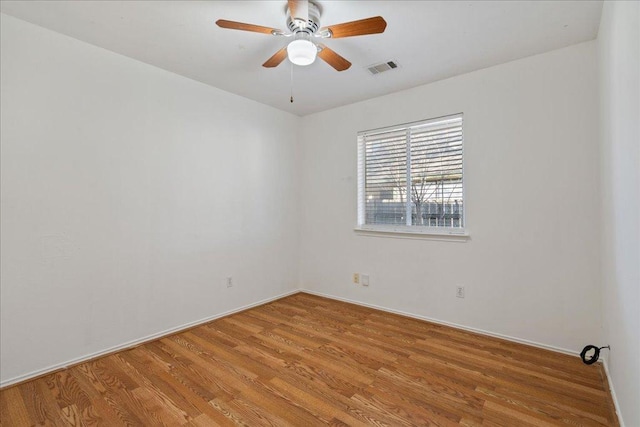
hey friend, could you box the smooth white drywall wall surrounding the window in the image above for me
[300,42,601,352]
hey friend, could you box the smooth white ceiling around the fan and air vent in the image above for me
[0,0,602,116]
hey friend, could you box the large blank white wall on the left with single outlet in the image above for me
[0,15,299,384]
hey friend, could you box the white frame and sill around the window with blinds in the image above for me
[354,113,470,242]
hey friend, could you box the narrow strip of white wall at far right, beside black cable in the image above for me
[598,1,640,426]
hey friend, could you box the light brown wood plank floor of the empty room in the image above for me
[0,293,617,427]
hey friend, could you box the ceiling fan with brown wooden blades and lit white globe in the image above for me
[216,0,387,71]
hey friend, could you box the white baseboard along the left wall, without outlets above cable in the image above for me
[0,289,300,388]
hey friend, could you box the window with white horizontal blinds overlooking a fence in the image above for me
[358,114,464,234]
